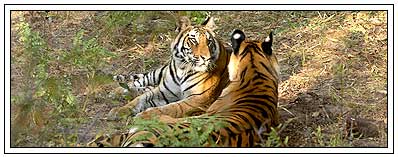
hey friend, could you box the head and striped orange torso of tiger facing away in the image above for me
[207,30,279,147]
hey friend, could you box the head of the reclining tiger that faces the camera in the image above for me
[171,17,220,72]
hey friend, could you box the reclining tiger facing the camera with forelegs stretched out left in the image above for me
[108,17,233,119]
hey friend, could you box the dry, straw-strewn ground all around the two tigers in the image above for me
[11,11,387,147]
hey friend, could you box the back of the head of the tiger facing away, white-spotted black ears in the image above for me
[228,30,279,81]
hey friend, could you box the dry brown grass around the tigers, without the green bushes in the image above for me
[11,11,387,147]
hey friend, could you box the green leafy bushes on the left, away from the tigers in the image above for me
[12,15,114,146]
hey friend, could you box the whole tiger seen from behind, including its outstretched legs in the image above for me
[89,29,279,147]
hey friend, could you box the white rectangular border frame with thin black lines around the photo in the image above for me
[0,2,398,156]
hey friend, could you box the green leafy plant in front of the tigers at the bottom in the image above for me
[126,116,225,147]
